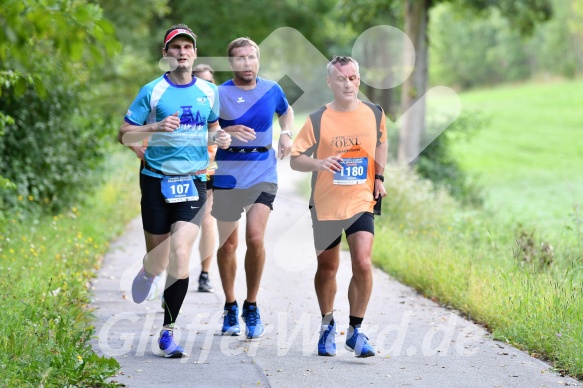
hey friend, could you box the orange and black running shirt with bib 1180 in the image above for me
[291,102,387,221]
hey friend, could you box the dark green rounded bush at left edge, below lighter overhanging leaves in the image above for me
[0,70,113,215]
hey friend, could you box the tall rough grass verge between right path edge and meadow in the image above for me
[373,168,583,378]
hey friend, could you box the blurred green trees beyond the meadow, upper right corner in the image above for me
[429,0,583,89]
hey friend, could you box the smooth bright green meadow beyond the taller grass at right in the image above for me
[454,80,583,232]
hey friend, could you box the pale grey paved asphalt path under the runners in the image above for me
[92,159,581,387]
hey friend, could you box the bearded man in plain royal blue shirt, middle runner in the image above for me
[212,38,294,338]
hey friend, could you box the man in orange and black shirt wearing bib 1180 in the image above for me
[291,56,387,357]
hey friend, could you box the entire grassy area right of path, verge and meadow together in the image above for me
[373,81,583,379]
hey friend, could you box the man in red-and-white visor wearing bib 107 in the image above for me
[118,25,231,358]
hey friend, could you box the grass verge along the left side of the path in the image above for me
[0,150,139,386]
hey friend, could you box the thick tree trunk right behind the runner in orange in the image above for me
[398,0,430,164]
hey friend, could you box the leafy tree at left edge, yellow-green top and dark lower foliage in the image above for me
[0,0,119,215]
